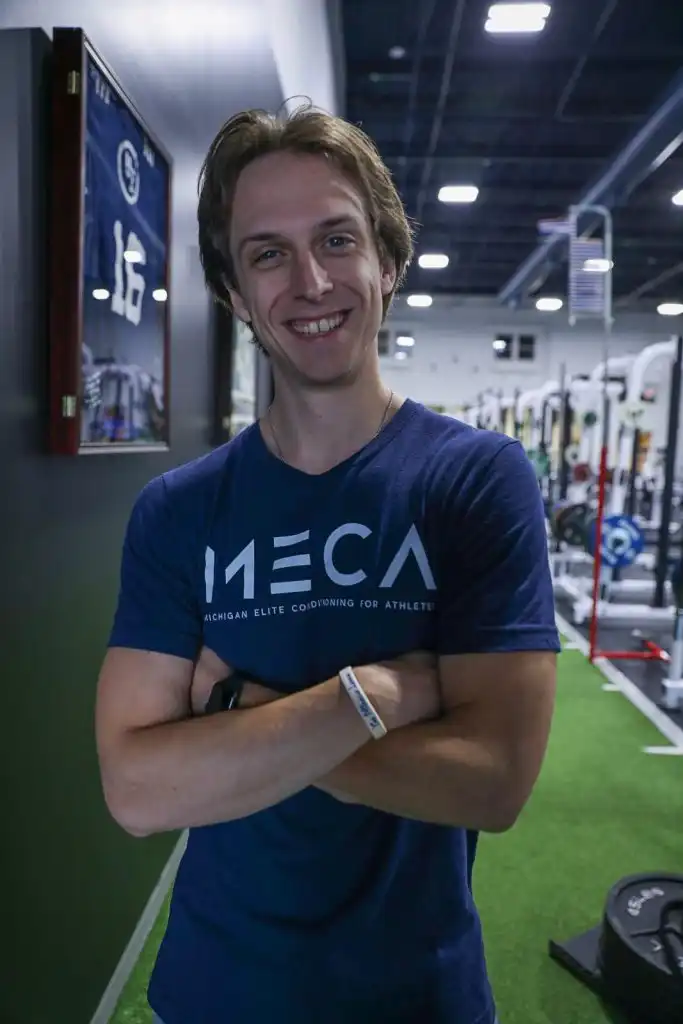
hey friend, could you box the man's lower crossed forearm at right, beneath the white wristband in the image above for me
[317,713,516,833]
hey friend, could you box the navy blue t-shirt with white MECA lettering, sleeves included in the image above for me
[111,400,559,1024]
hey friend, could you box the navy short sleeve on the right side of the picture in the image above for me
[437,441,560,654]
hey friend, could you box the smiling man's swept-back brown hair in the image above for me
[198,104,414,316]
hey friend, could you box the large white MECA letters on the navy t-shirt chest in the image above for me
[204,522,436,604]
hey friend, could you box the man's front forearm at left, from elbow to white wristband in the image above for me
[111,679,370,836]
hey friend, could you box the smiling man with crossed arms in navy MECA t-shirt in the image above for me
[97,103,558,1024]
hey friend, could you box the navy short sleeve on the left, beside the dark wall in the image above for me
[109,476,202,659]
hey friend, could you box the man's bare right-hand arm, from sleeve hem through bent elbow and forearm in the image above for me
[318,651,556,831]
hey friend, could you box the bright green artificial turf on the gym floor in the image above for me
[110,637,683,1024]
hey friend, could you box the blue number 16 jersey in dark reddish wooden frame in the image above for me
[48,29,172,455]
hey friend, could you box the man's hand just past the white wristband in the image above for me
[354,651,441,731]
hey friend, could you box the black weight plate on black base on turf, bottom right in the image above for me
[549,873,683,1024]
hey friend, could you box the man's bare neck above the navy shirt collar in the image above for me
[261,378,402,474]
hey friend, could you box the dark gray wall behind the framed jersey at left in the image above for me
[0,30,218,1024]
